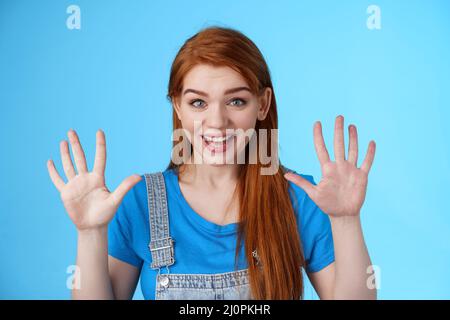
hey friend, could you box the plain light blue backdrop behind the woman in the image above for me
[0,0,450,299]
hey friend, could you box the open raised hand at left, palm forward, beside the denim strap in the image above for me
[47,130,141,231]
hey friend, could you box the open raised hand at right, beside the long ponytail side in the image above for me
[285,116,375,217]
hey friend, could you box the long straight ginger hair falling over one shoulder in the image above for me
[167,27,305,300]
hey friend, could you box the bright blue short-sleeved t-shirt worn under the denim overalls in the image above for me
[108,169,334,300]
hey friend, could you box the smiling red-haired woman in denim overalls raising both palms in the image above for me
[47,27,376,299]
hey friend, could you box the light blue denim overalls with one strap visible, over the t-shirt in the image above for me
[144,172,256,300]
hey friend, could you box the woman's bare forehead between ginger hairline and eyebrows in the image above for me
[183,64,248,94]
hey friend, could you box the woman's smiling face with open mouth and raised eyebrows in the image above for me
[174,64,272,165]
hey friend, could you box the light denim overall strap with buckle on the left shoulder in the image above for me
[144,172,175,269]
